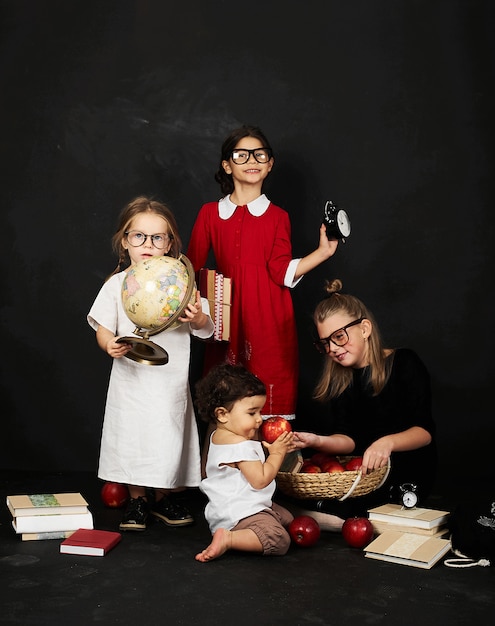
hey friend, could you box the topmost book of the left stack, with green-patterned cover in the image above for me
[7,493,88,517]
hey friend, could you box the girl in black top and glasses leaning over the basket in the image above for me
[294,280,436,518]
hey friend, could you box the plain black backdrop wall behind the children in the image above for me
[0,0,495,488]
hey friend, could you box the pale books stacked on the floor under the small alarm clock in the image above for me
[365,504,451,569]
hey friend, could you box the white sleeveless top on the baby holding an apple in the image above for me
[200,438,275,534]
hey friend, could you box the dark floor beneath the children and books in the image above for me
[0,472,495,626]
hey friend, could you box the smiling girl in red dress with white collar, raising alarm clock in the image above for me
[187,126,338,419]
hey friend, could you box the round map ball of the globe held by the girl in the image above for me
[122,255,196,336]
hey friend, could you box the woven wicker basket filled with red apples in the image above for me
[277,456,390,500]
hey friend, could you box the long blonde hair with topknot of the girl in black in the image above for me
[313,278,392,401]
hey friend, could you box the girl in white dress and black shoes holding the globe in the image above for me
[88,197,213,530]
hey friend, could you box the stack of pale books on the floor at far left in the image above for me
[7,493,93,541]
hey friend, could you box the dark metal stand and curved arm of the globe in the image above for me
[117,254,196,365]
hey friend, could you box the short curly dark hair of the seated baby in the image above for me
[195,363,266,423]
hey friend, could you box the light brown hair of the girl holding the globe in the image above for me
[107,196,182,280]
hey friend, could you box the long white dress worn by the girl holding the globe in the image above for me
[87,272,213,489]
